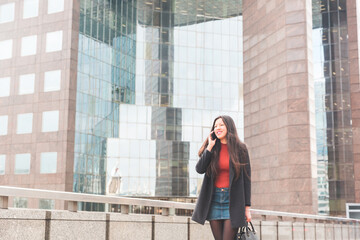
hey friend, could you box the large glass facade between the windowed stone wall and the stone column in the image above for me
[74,0,243,210]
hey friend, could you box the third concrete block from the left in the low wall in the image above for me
[109,213,152,240]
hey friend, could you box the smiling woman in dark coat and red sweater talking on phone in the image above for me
[192,116,251,240]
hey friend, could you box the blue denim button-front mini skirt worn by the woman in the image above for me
[206,188,230,221]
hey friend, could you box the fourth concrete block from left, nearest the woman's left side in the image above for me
[155,216,188,240]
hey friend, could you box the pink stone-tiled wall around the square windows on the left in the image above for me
[0,0,79,206]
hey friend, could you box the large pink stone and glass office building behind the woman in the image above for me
[0,0,360,215]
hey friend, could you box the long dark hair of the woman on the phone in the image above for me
[199,115,247,178]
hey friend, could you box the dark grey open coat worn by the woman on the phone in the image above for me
[192,147,251,228]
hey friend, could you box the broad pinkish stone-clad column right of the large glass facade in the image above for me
[243,0,317,214]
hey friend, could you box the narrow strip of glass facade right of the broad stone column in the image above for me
[313,0,355,215]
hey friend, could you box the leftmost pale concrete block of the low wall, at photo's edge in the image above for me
[0,209,46,240]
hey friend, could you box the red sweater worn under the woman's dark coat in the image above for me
[215,144,230,188]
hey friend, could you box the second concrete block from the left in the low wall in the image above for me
[50,211,106,240]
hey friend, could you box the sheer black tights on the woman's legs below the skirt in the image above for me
[210,219,238,240]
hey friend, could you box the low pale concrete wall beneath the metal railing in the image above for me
[0,209,360,240]
